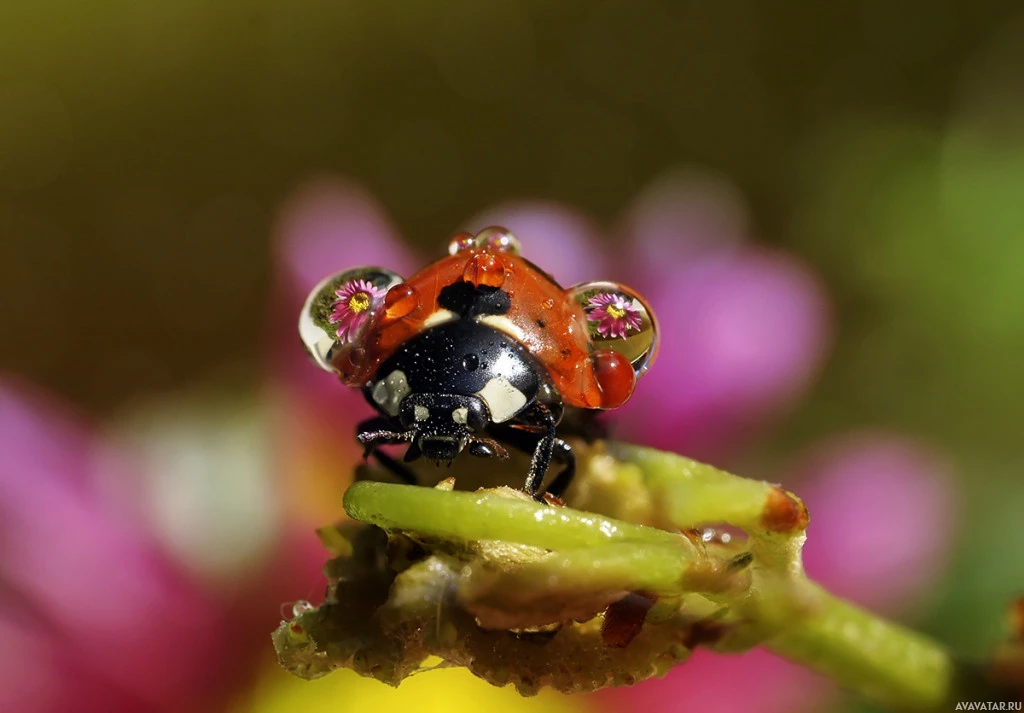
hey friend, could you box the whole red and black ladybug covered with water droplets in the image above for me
[299,226,657,498]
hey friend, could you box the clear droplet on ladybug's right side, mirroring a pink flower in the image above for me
[566,282,657,376]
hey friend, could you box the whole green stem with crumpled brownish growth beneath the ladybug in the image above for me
[275,445,987,711]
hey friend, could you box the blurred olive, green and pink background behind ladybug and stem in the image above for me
[0,0,1024,713]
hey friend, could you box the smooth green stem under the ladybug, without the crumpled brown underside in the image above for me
[337,445,955,710]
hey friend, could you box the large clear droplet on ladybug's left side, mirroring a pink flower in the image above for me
[299,267,401,371]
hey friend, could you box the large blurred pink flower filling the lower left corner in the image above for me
[0,382,228,713]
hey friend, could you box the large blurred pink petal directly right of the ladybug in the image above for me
[620,250,828,462]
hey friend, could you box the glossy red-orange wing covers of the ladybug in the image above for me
[332,246,636,409]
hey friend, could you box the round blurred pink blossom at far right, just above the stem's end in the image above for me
[794,433,956,613]
